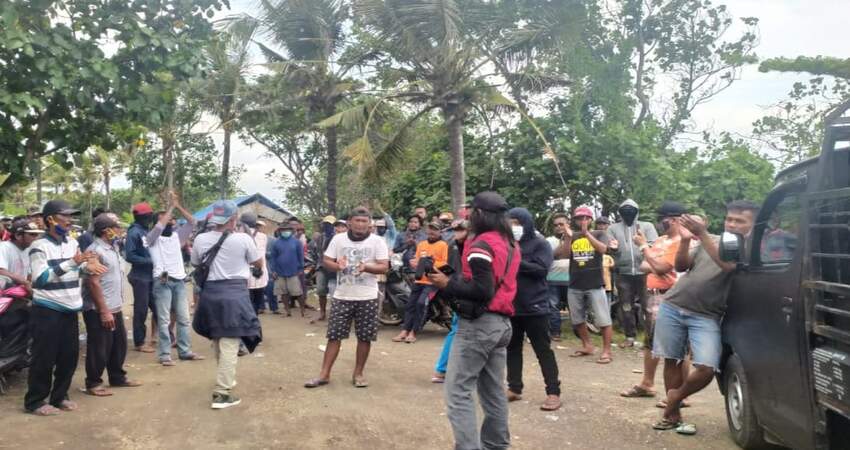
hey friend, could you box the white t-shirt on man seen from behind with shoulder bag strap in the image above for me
[192,231,261,281]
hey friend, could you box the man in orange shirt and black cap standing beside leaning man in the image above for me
[620,201,688,397]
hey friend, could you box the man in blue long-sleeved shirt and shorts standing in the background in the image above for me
[269,223,304,317]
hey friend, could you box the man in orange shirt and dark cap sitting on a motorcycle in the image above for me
[393,222,449,344]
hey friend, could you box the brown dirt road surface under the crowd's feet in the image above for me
[0,304,735,450]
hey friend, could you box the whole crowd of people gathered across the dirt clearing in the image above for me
[0,192,758,449]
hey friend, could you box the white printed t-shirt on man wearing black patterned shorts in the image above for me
[325,233,390,300]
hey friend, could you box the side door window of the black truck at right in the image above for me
[754,194,800,265]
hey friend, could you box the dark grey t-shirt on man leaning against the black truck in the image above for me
[664,235,733,320]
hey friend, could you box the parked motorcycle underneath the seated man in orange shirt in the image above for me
[378,254,452,329]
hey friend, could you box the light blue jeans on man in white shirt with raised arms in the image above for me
[153,278,192,361]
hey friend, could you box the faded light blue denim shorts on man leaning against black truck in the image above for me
[652,302,723,371]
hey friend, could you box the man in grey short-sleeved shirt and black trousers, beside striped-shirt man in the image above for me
[82,213,142,397]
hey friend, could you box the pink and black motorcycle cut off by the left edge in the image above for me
[0,286,32,394]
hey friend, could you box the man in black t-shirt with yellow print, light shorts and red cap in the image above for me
[555,206,613,364]
